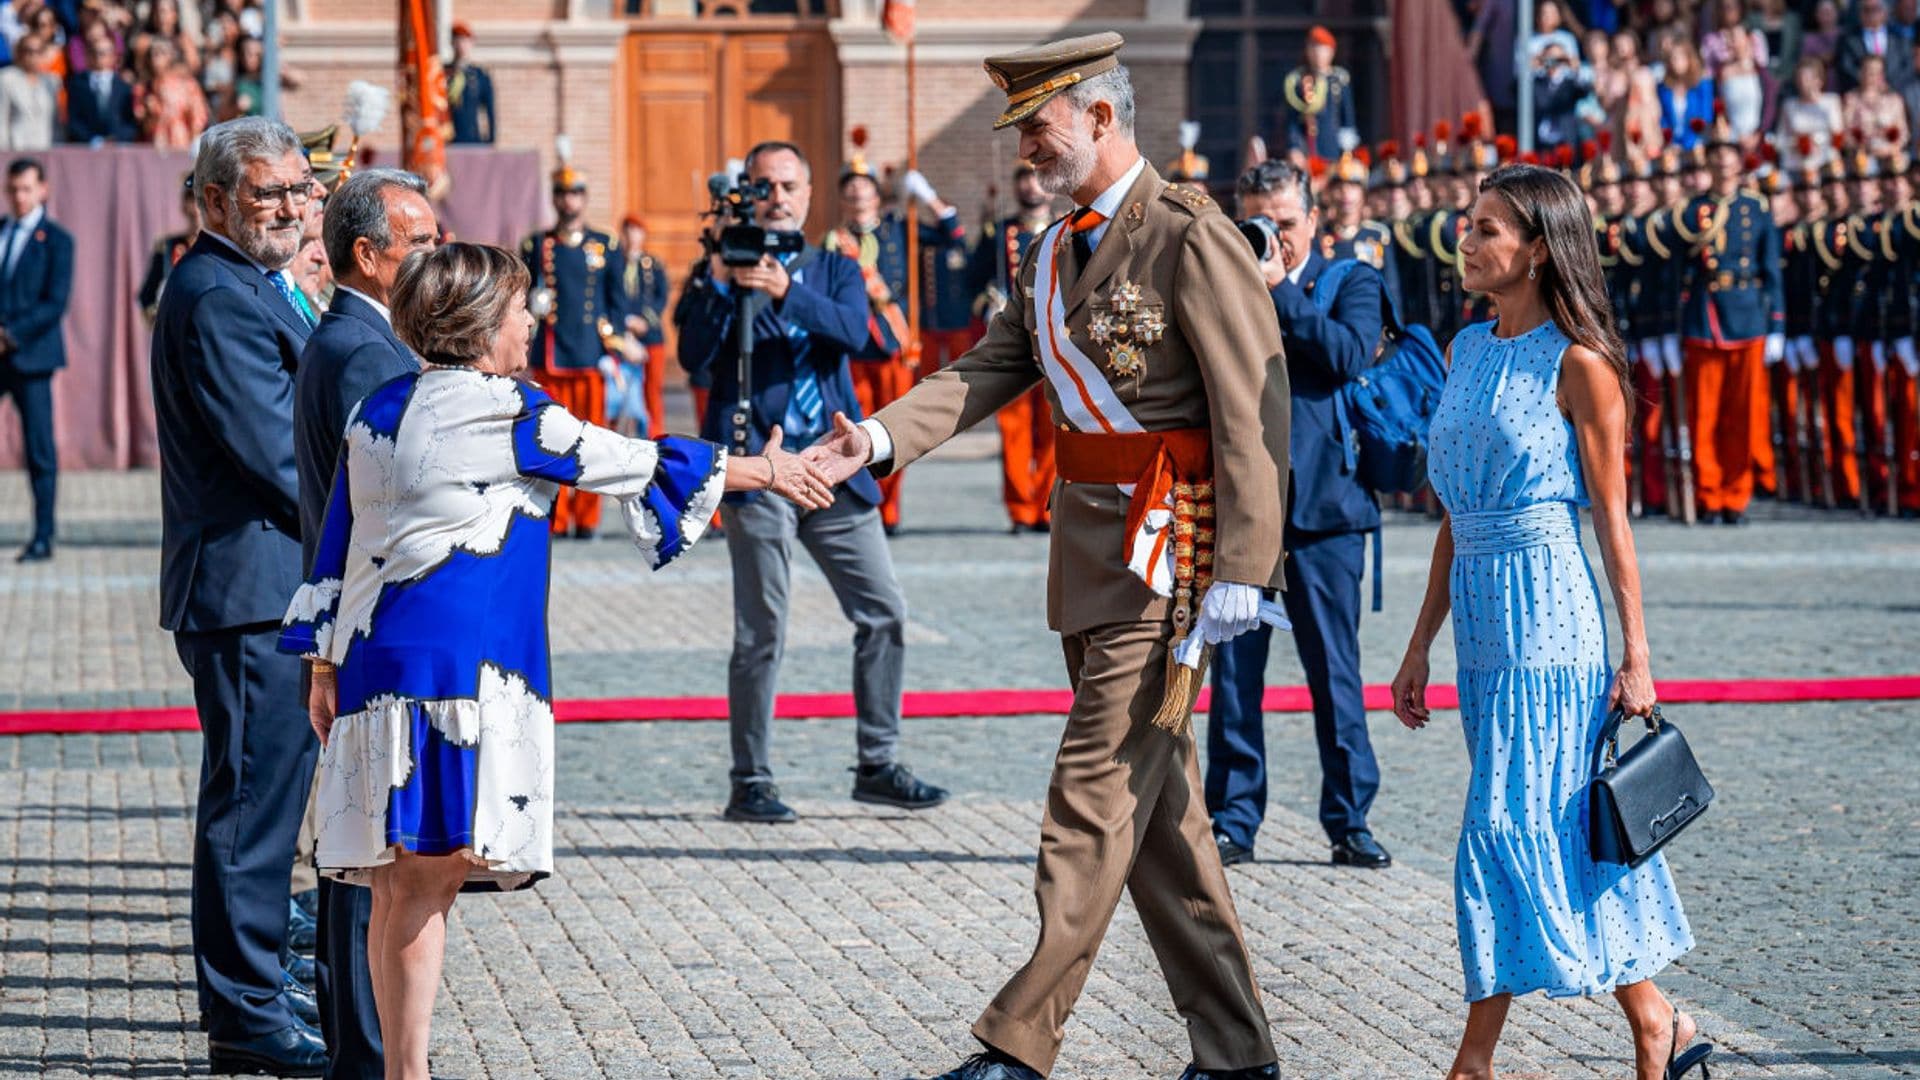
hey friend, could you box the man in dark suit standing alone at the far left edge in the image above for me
[0,158,73,563]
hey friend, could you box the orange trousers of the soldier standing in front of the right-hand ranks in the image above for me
[1680,340,1766,515]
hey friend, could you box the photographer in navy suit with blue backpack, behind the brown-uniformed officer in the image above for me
[1206,161,1392,867]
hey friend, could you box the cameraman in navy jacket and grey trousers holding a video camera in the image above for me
[680,142,947,822]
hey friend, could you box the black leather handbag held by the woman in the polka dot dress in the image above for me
[1588,705,1713,867]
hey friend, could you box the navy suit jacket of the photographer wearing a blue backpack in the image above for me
[1273,252,1384,532]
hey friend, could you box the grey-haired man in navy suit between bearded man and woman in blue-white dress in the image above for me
[294,169,440,1080]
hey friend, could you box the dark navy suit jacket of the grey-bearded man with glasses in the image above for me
[150,233,311,630]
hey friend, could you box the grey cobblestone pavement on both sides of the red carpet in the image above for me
[0,444,1920,1080]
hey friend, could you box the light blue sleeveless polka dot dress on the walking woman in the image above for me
[1428,323,1693,1001]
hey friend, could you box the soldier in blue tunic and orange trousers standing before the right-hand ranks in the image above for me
[1674,115,1786,525]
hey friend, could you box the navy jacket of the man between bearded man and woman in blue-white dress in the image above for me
[294,288,420,575]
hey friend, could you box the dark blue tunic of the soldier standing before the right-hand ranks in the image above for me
[1674,192,1786,346]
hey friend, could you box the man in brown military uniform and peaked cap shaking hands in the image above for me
[808,33,1288,1080]
